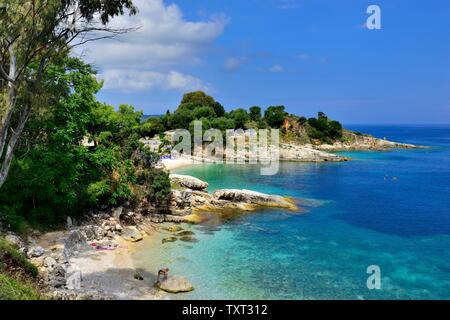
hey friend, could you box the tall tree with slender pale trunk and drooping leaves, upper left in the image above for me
[0,0,137,188]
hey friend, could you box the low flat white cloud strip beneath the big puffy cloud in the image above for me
[99,69,209,92]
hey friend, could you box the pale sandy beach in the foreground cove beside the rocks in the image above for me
[32,226,169,300]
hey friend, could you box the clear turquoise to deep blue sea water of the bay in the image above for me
[137,126,450,299]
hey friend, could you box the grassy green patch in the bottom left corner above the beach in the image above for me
[0,237,43,300]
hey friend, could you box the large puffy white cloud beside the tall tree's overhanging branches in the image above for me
[78,0,228,90]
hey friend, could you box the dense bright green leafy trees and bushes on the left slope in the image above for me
[0,58,171,229]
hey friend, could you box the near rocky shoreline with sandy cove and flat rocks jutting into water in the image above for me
[1,175,298,300]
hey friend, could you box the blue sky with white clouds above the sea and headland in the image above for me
[77,0,450,124]
